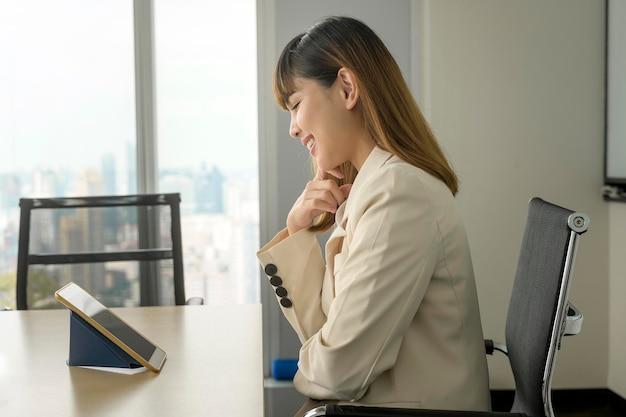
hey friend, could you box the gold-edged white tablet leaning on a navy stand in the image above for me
[54,282,167,372]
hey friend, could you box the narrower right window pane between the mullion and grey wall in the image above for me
[154,0,260,303]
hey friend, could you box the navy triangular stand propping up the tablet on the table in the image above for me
[67,311,142,368]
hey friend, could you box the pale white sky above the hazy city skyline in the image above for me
[0,0,258,173]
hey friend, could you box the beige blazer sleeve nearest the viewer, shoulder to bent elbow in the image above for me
[294,166,444,401]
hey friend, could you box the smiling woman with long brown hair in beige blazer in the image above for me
[257,17,490,413]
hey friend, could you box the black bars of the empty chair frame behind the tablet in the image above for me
[16,193,185,310]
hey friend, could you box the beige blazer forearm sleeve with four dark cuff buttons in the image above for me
[257,229,326,343]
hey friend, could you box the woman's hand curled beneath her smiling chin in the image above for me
[287,169,352,235]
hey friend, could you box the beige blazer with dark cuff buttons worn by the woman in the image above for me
[257,148,490,410]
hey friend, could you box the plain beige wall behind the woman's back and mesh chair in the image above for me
[423,0,608,388]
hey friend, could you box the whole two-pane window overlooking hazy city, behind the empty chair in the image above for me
[0,0,260,306]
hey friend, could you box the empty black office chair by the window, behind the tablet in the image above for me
[16,193,202,310]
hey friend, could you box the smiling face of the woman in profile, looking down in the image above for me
[287,77,371,172]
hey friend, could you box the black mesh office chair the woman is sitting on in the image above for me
[305,198,589,417]
